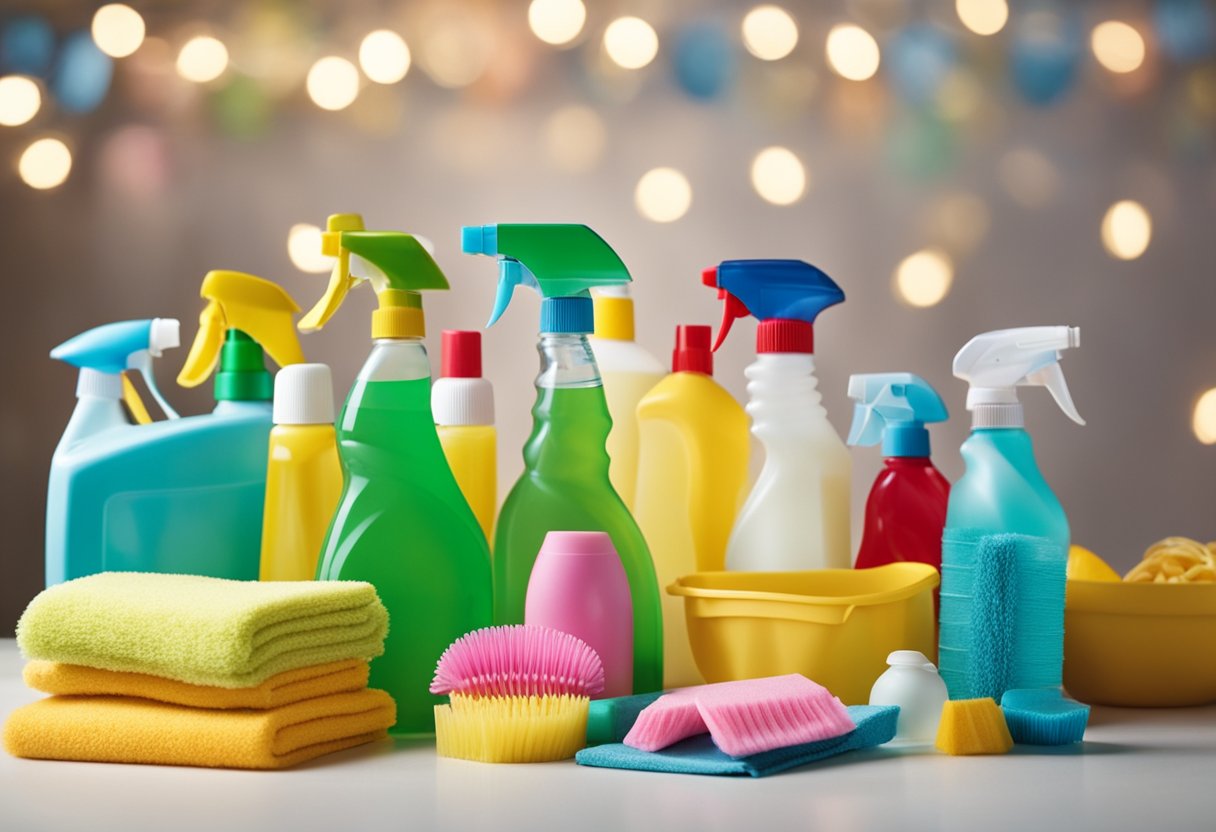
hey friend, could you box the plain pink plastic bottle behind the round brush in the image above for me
[524,532,634,698]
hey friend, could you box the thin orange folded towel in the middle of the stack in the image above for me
[24,659,367,709]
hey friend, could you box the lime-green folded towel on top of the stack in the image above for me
[17,572,388,687]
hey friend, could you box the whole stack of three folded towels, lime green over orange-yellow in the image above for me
[4,573,396,769]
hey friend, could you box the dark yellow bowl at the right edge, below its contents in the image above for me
[1064,580,1216,708]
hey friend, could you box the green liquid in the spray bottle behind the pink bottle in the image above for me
[494,379,663,693]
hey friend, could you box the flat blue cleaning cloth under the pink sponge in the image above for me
[574,705,900,777]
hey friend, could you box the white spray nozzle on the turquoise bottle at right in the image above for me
[955,326,1085,427]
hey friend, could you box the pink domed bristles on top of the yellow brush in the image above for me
[430,624,604,697]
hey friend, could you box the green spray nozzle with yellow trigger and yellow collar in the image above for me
[299,214,449,338]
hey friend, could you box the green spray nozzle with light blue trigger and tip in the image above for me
[461,224,631,332]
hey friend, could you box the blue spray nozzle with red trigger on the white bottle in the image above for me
[702,260,844,350]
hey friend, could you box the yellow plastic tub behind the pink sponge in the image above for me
[668,563,940,704]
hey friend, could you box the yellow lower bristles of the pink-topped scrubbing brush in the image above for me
[435,693,591,763]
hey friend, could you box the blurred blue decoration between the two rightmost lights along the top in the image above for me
[1010,6,1085,106]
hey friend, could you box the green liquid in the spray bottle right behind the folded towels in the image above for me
[317,378,492,733]
